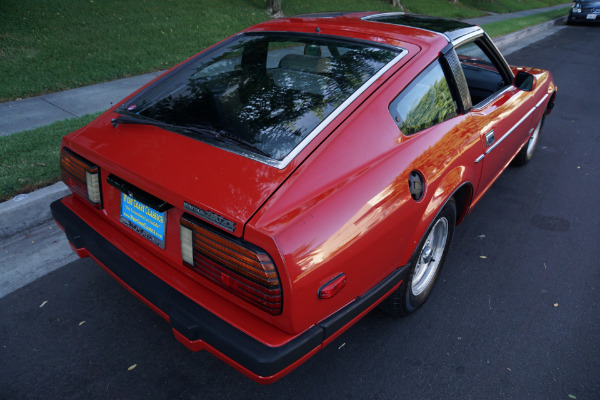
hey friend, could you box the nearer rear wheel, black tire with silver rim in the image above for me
[380,199,456,317]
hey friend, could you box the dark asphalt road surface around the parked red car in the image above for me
[0,26,600,400]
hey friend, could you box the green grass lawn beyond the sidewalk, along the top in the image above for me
[0,0,565,102]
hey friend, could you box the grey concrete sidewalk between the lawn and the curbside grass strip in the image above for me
[0,3,571,136]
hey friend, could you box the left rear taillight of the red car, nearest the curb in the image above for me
[60,147,102,208]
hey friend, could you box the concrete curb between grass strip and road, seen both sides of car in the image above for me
[0,16,567,244]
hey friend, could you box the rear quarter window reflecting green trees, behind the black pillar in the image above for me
[389,60,457,135]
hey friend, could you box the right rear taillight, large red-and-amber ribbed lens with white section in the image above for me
[181,215,282,315]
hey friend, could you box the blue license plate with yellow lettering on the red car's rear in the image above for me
[120,193,167,249]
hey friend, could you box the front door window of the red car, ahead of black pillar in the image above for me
[455,41,508,107]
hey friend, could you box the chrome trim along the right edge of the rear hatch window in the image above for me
[246,48,408,169]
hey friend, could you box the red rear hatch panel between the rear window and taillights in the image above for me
[65,112,293,236]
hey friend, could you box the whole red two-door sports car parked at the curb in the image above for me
[51,12,556,383]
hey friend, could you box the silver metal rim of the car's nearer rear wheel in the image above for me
[411,217,448,296]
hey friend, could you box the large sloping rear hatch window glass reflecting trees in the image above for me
[117,34,400,160]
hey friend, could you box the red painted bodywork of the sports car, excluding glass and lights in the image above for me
[53,13,556,383]
